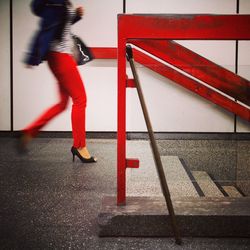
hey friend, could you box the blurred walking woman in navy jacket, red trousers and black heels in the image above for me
[21,0,96,163]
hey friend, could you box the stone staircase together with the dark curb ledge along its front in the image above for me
[98,141,250,237]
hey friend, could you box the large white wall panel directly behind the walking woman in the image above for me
[13,0,123,131]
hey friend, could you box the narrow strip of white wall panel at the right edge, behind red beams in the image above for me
[237,0,250,132]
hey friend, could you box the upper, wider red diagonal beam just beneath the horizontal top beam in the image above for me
[132,40,250,106]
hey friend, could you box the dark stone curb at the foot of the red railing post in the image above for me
[98,197,250,237]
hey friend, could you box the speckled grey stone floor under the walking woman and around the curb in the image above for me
[0,137,250,250]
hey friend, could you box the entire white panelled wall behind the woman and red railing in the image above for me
[0,0,250,132]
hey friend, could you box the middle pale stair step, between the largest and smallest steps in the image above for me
[192,171,224,197]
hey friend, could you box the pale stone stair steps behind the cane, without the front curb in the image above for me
[127,141,243,198]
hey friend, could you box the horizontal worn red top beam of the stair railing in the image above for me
[118,14,250,40]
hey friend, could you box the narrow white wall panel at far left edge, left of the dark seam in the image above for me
[0,0,11,130]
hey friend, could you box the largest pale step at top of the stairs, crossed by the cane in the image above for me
[127,156,199,197]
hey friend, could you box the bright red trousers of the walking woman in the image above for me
[23,52,87,148]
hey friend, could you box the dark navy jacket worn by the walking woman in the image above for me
[25,0,81,65]
